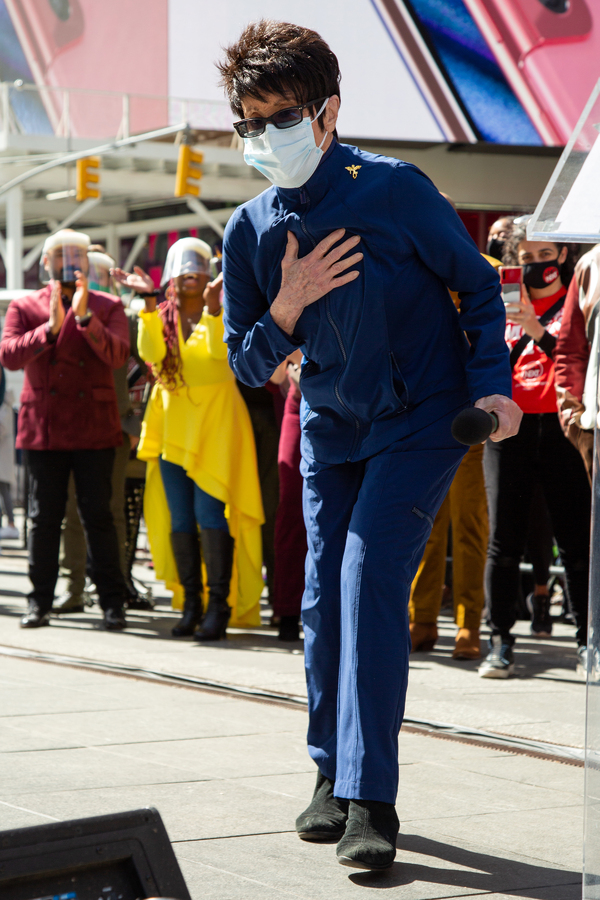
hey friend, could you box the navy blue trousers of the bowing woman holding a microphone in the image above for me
[302,413,466,803]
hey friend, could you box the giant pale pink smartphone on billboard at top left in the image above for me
[4,0,168,138]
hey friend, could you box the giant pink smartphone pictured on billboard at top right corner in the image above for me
[463,0,600,145]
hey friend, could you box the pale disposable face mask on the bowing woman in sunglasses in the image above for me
[244,97,329,188]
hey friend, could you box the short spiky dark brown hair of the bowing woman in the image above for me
[217,19,341,125]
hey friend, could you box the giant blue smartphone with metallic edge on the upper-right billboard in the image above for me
[371,0,544,145]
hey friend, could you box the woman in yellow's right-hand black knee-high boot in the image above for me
[194,528,234,641]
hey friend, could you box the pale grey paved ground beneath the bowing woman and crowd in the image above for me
[0,541,585,900]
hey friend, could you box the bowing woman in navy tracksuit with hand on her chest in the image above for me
[220,15,520,868]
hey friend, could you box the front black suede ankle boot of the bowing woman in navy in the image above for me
[335,800,400,869]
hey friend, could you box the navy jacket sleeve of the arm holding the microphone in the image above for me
[391,166,512,402]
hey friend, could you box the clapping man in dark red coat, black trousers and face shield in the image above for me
[0,229,129,630]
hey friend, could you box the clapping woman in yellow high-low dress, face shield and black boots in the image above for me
[114,238,263,641]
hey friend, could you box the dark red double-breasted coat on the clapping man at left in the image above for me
[0,285,129,450]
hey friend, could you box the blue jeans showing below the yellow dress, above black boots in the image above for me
[159,459,229,534]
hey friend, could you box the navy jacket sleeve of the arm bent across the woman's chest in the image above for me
[223,213,301,387]
